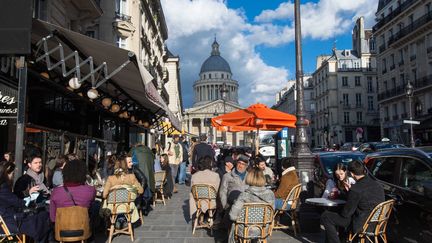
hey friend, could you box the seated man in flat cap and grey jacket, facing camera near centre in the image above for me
[219,155,249,209]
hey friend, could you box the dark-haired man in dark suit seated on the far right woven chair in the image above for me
[321,161,385,243]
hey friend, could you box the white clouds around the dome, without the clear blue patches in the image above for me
[161,0,377,107]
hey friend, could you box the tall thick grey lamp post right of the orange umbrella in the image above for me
[291,0,314,191]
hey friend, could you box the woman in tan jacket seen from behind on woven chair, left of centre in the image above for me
[102,157,144,223]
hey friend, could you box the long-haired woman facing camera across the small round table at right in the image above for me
[322,163,355,199]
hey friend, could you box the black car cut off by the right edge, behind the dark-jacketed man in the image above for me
[364,148,432,243]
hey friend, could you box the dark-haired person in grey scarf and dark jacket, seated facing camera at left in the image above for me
[14,155,49,198]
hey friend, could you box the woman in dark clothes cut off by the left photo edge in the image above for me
[0,161,50,242]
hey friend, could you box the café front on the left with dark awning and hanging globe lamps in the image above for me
[0,20,180,175]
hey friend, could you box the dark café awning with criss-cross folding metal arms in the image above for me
[32,19,181,130]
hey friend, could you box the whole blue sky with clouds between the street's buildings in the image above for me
[161,0,378,108]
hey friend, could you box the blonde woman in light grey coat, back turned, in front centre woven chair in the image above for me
[229,167,275,242]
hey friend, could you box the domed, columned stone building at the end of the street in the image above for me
[183,39,250,146]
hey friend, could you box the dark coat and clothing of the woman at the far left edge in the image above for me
[0,183,49,240]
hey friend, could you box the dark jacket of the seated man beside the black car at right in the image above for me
[341,176,385,232]
